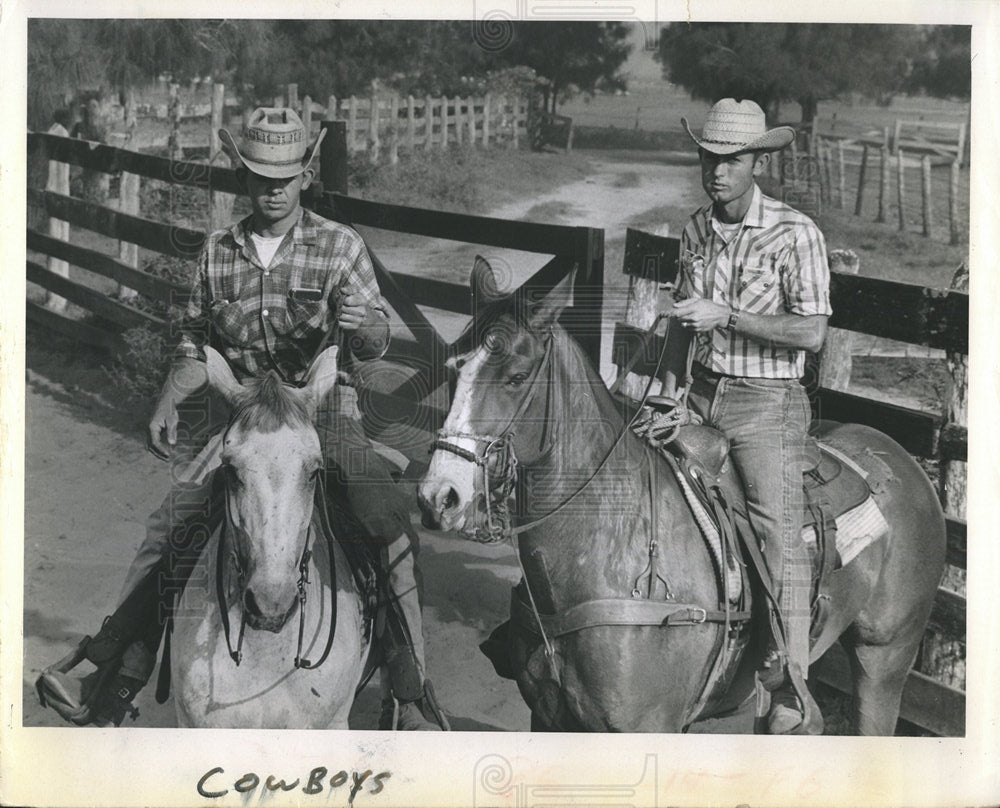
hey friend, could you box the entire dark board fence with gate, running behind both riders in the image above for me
[27,121,968,735]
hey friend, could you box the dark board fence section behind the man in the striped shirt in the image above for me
[612,230,969,736]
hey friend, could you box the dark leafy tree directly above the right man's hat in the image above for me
[657,23,920,123]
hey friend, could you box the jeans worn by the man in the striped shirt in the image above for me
[688,376,812,676]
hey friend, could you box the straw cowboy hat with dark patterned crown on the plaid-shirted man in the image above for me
[219,107,326,179]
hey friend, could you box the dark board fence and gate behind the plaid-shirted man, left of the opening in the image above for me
[27,121,604,448]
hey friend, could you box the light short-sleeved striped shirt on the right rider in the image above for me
[678,186,831,379]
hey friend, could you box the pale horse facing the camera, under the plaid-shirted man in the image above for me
[171,348,369,729]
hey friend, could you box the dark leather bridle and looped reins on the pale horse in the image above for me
[215,428,337,670]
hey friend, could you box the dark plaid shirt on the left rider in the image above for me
[175,209,386,381]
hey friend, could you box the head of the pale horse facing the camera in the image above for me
[207,347,337,631]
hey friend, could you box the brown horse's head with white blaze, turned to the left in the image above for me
[418,256,572,541]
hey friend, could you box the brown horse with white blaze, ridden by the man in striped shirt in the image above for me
[419,259,945,735]
